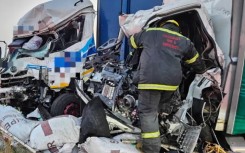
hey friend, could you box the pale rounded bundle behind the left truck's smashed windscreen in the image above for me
[22,36,43,50]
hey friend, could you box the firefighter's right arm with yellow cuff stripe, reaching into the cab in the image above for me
[183,42,206,74]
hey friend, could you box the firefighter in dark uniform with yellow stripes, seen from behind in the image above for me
[130,20,205,153]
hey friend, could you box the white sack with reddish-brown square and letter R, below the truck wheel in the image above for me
[30,115,81,150]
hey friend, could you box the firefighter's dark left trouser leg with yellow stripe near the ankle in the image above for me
[138,90,161,153]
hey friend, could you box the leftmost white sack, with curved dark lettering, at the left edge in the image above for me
[0,105,39,142]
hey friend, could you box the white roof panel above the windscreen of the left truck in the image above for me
[14,0,93,36]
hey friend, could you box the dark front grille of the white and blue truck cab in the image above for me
[1,70,28,88]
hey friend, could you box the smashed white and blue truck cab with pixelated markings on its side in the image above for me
[0,0,96,116]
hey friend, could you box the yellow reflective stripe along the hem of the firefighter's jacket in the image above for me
[138,84,179,91]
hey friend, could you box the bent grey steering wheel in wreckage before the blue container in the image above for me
[97,38,122,52]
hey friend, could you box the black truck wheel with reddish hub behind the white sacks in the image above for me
[50,93,86,117]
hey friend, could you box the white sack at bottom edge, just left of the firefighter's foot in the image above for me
[80,137,140,153]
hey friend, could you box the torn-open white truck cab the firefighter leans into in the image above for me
[119,0,225,99]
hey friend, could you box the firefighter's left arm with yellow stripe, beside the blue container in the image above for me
[129,30,145,49]
